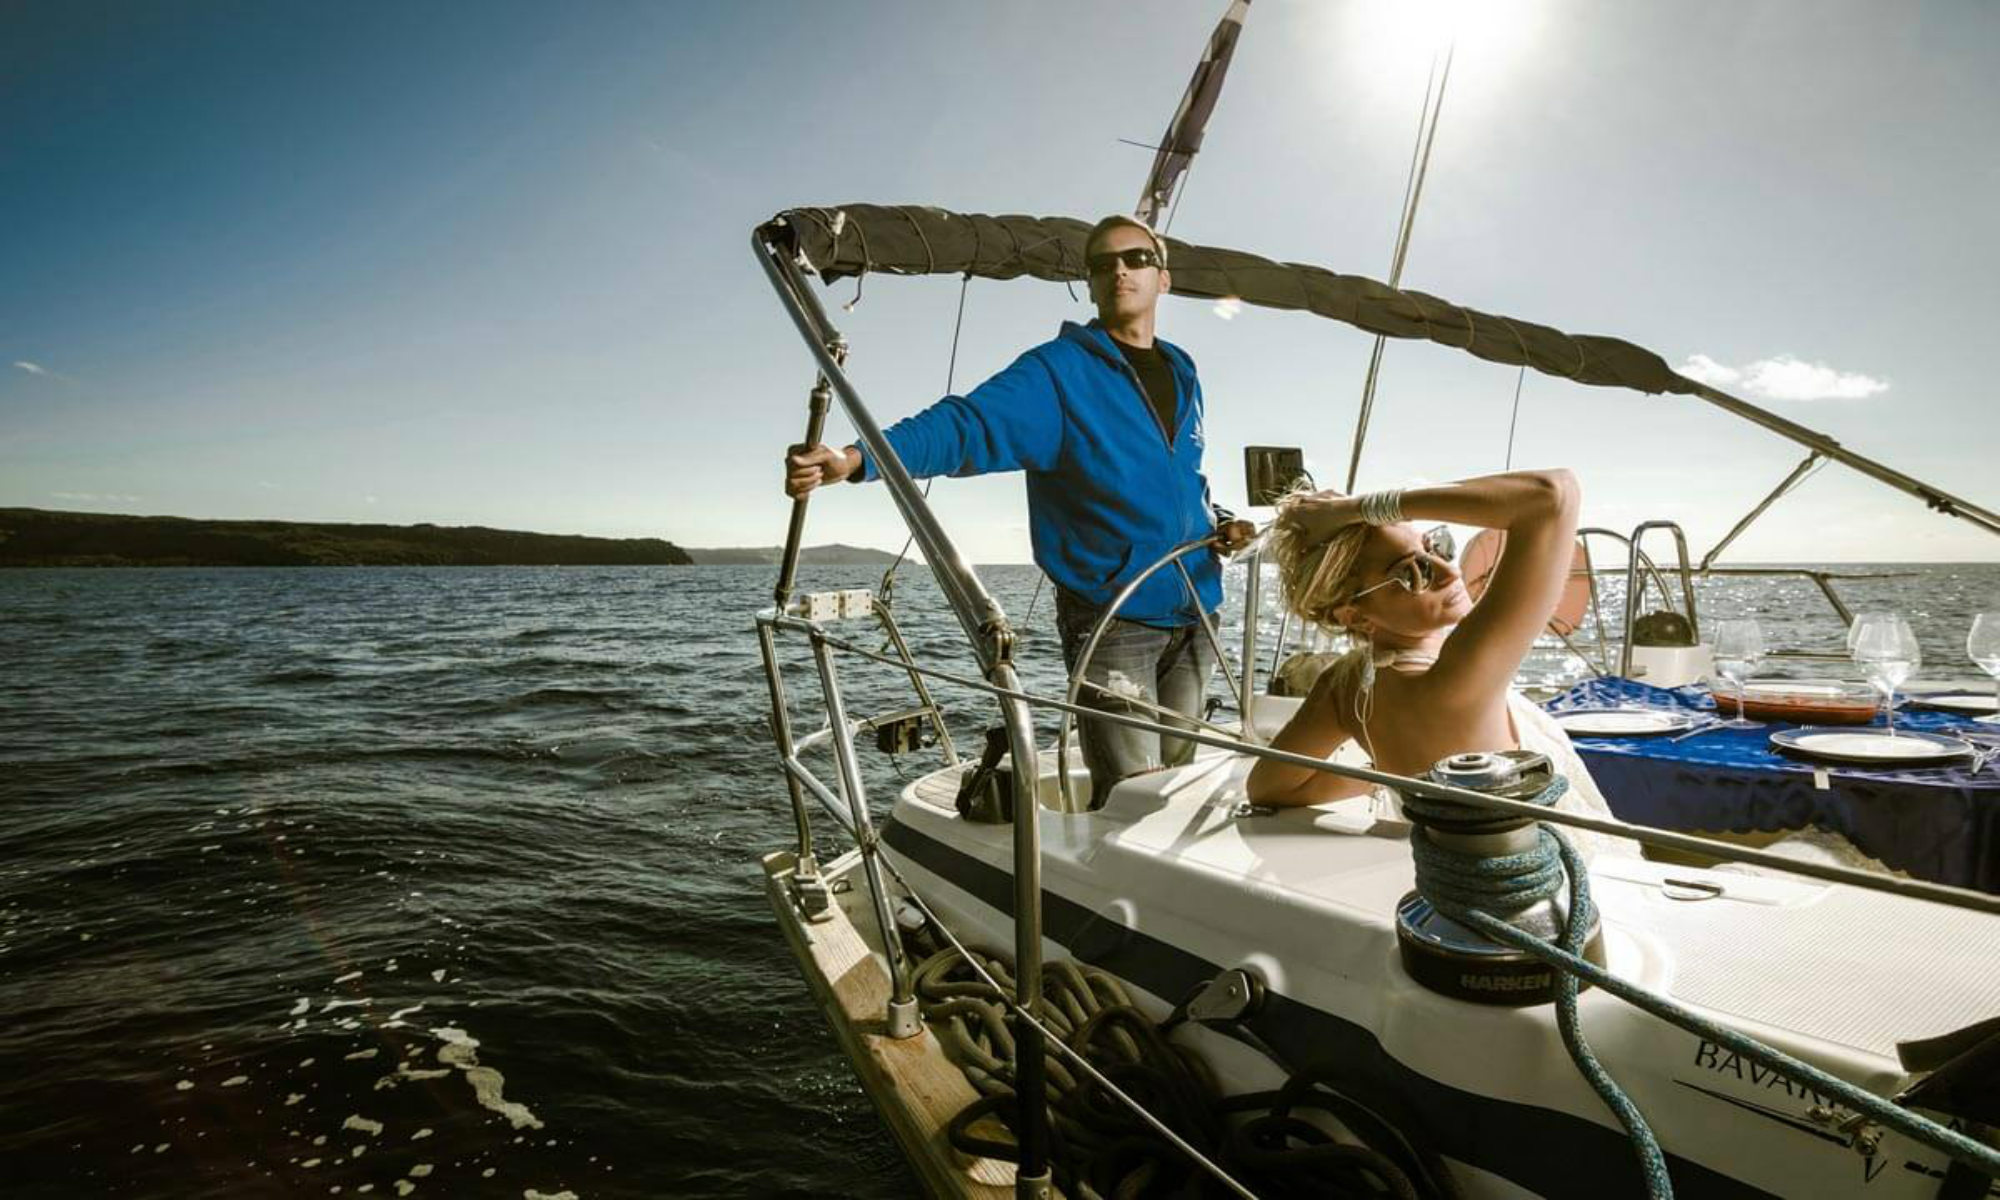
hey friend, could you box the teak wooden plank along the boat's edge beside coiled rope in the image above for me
[764,850,1014,1200]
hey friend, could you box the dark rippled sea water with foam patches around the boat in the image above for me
[0,564,2000,1200]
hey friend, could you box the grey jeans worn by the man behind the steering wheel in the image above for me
[1056,590,1216,808]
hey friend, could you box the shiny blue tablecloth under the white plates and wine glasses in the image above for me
[1548,680,2000,892]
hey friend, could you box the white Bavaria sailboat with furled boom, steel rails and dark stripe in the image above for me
[752,0,2000,1198]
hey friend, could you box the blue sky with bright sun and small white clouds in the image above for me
[0,0,2000,562]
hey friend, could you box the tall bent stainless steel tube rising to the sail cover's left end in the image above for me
[750,226,1052,1198]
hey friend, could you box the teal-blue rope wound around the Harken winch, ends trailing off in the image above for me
[1404,776,2000,1200]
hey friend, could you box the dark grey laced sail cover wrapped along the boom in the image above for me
[770,204,1706,394]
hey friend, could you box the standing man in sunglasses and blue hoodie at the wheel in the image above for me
[784,216,1254,806]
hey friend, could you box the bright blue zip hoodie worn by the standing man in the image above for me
[858,320,1222,626]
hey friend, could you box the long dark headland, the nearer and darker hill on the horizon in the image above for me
[0,508,688,566]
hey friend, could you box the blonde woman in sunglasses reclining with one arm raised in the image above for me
[1248,470,1636,852]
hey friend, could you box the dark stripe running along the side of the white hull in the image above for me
[882,820,1772,1200]
